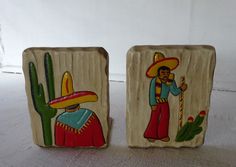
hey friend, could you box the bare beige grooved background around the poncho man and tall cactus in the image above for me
[23,47,109,146]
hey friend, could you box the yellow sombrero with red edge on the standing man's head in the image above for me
[146,52,179,78]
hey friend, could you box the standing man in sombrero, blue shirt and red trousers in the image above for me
[144,52,187,142]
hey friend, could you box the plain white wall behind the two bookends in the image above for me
[0,0,236,87]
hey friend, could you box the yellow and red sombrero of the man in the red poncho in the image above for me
[49,71,98,109]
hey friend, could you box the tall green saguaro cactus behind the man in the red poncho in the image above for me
[29,53,57,146]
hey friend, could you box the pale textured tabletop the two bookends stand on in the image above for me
[0,73,236,167]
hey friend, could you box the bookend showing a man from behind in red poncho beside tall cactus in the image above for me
[23,47,109,148]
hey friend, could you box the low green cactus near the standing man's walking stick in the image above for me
[175,112,205,142]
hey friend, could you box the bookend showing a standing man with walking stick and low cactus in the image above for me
[126,45,216,148]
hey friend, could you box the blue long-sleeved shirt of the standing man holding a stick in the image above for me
[149,77,181,106]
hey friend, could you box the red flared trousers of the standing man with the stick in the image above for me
[144,102,170,140]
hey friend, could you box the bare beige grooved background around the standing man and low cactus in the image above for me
[126,46,216,147]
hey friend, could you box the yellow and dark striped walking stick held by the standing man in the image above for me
[178,76,185,131]
